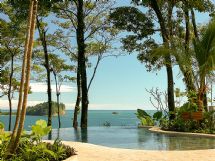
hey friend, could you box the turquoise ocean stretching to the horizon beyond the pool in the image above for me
[0,110,155,130]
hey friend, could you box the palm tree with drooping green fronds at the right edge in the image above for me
[193,20,215,111]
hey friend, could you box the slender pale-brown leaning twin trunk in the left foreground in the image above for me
[8,0,38,155]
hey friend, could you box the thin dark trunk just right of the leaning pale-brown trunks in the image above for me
[37,17,52,126]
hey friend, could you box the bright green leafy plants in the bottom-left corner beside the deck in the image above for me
[0,120,76,161]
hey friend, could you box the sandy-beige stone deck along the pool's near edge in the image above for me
[63,141,215,161]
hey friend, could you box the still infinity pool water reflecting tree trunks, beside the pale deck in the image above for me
[45,126,215,150]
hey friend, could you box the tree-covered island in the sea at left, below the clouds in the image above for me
[26,102,65,116]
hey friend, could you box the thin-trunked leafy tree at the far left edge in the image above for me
[0,4,25,131]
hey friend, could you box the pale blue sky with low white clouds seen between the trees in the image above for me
[0,0,214,110]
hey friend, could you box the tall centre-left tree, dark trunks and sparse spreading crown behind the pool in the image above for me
[55,0,116,128]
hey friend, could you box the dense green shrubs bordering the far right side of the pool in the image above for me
[160,91,215,134]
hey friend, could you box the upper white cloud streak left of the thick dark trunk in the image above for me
[30,82,75,93]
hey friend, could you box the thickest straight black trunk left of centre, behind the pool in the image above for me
[77,0,89,128]
